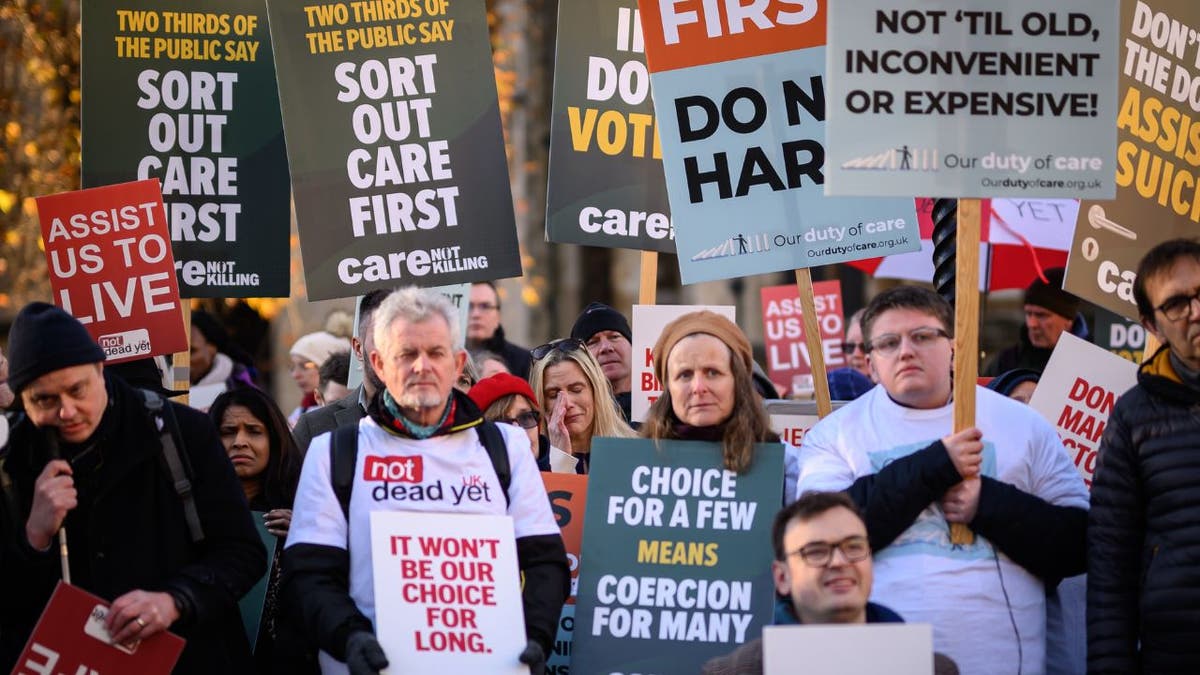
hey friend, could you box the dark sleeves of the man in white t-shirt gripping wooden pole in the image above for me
[846,441,1087,578]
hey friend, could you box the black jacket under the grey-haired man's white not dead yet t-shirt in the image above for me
[281,390,571,661]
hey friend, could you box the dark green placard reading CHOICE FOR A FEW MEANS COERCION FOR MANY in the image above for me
[571,438,784,675]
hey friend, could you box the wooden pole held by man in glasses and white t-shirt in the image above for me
[950,199,982,545]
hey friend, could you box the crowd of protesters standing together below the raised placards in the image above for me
[0,239,1200,675]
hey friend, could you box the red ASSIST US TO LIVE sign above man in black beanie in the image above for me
[37,178,187,363]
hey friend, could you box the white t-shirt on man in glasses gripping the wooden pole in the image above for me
[799,387,1088,675]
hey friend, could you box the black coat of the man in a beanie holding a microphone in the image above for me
[0,376,266,675]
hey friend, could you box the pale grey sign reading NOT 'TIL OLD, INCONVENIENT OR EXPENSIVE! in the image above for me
[826,0,1118,199]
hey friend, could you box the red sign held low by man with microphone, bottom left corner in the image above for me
[12,581,184,675]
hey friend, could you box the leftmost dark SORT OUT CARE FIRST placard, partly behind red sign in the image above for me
[82,0,292,298]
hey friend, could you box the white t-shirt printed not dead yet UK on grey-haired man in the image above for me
[287,417,559,673]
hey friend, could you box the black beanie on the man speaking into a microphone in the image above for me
[8,303,104,396]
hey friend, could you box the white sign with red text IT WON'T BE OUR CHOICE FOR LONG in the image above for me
[371,510,528,675]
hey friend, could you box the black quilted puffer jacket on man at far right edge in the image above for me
[1087,347,1200,674]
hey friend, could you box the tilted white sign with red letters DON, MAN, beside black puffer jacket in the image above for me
[1030,333,1138,488]
